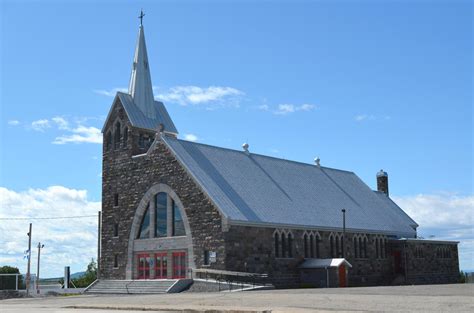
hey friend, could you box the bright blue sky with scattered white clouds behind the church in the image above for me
[0,0,474,275]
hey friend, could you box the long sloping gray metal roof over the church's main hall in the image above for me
[163,136,416,237]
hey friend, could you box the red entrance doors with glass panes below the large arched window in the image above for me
[137,252,186,279]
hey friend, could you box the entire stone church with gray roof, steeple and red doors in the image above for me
[99,20,459,287]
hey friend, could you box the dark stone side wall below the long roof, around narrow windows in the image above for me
[225,225,394,286]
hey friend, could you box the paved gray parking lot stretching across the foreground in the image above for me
[0,284,474,313]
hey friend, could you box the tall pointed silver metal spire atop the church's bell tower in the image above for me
[128,11,156,118]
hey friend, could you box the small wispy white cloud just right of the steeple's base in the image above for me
[155,86,244,109]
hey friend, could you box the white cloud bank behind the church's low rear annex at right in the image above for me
[392,193,474,270]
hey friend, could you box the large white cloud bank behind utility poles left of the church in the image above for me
[0,186,101,277]
